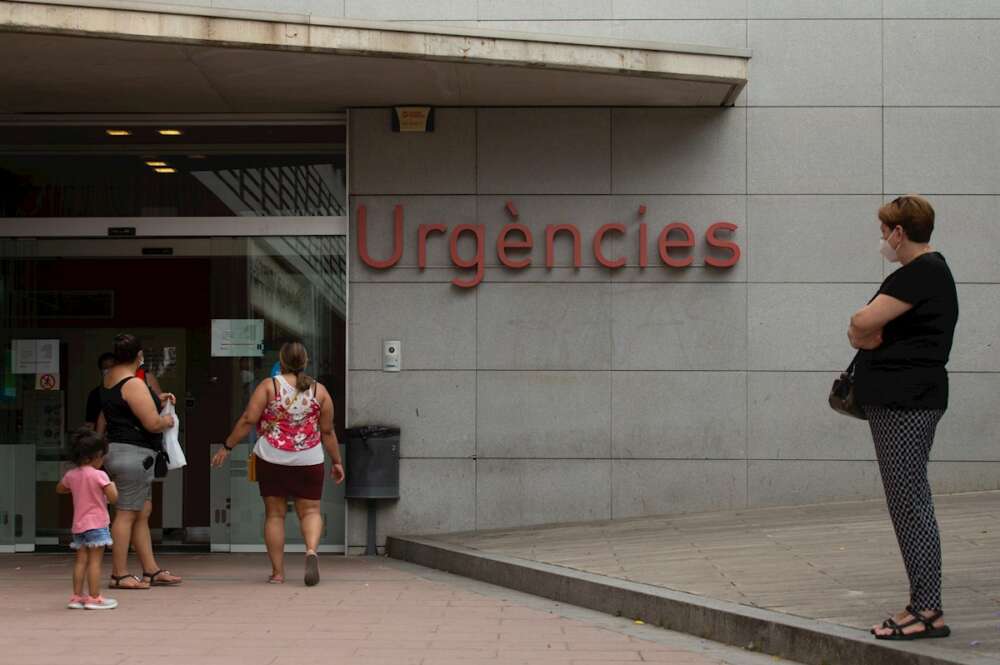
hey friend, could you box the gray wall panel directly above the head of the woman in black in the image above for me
[885,108,1000,194]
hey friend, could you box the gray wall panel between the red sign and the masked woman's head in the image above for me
[747,196,882,283]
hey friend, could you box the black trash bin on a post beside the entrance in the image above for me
[345,425,399,556]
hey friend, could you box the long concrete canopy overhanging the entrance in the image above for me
[0,0,750,113]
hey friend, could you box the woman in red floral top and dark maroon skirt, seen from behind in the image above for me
[212,342,344,586]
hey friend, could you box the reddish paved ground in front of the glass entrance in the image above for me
[0,553,800,665]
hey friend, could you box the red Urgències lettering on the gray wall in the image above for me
[357,203,740,288]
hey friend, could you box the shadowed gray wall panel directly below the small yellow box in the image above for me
[350,109,476,195]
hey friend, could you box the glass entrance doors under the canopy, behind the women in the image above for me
[0,231,347,551]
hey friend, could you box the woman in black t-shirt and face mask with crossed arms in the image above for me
[847,196,958,640]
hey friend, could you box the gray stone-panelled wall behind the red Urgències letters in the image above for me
[86,0,1000,544]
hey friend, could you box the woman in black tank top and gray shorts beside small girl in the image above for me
[97,334,181,589]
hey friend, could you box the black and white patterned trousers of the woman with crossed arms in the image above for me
[865,406,944,612]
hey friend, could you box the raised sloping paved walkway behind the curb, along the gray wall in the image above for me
[434,492,1000,662]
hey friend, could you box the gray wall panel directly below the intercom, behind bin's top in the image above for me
[347,371,476,458]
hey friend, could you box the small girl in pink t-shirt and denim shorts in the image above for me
[56,427,118,610]
